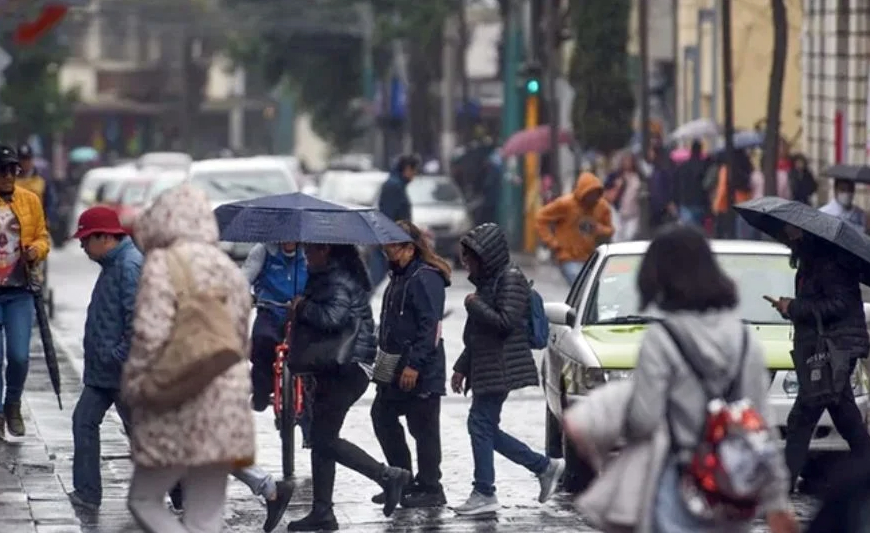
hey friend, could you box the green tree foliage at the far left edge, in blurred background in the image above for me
[0,32,78,139]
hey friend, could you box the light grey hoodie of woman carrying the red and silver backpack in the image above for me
[624,311,789,511]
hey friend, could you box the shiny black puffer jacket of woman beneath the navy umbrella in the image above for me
[296,262,377,364]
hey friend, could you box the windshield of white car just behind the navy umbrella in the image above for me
[190,169,296,202]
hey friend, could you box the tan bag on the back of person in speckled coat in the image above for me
[134,248,246,413]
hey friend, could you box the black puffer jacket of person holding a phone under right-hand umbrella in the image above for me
[788,244,870,359]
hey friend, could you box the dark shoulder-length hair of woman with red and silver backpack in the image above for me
[637,224,738,313]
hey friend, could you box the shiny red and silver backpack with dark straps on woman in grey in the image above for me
[662,321,779,521]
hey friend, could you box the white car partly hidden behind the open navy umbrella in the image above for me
[188,157,299,261]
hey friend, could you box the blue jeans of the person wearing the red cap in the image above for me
[73,385,130,503]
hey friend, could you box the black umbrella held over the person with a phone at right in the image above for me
[734,196,870,285]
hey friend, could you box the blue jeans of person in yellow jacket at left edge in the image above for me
[0,289,33,403]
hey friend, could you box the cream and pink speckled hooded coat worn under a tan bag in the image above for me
[121,184,255,468]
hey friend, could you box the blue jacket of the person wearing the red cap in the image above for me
[83,237,142,390]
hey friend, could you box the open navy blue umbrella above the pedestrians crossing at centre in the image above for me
[214,192,411,245]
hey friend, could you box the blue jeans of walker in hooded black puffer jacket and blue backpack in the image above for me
[468,394,550,496]
